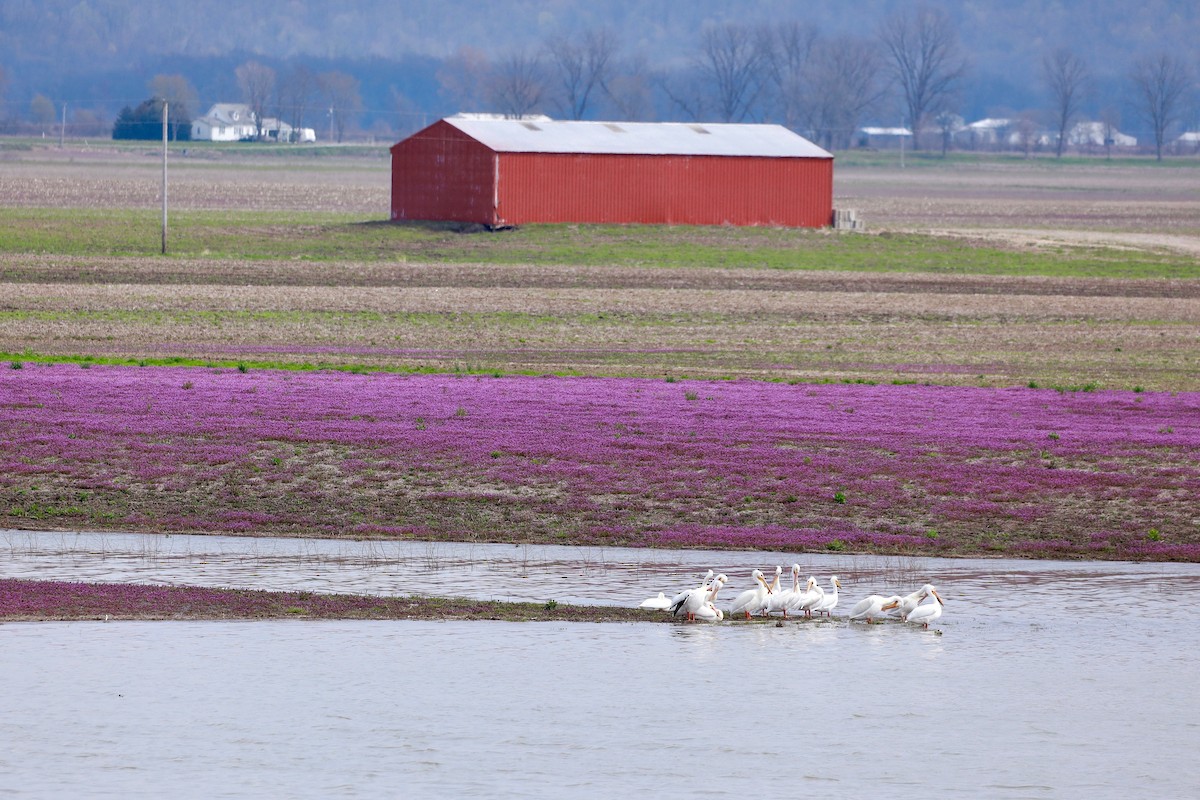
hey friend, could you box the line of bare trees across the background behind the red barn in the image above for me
[0,6,1196,158]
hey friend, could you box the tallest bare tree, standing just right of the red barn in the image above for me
[878,6,967,150]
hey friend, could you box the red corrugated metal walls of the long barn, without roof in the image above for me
[391,120,833,228]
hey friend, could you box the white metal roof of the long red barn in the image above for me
[445,115,833,158]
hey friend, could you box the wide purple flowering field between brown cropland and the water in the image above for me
[0,365,1200,560]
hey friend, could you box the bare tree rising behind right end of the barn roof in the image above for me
[799,36,884,150]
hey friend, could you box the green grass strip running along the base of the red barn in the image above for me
[0,207,1195,278]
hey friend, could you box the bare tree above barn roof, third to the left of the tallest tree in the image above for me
[697,23,766,122]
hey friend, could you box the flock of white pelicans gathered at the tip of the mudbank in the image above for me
[638,564,946,630]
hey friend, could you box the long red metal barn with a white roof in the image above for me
[391,115,833,228]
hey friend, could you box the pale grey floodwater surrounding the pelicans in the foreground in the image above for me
[0,531,1200,798]
